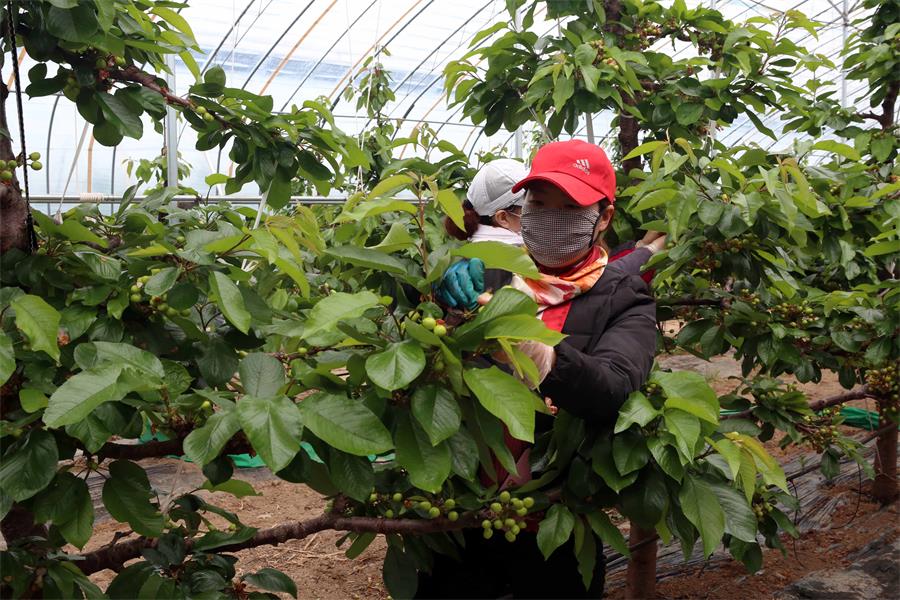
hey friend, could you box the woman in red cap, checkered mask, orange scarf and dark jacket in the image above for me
[418,140,656,598]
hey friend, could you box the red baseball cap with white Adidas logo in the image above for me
[512,140,616,206]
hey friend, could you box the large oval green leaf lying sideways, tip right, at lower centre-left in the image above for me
[300,393,394,456]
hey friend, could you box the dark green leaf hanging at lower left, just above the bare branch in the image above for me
[103,460,165,537]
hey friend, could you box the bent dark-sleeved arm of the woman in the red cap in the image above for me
[541,276,656,425]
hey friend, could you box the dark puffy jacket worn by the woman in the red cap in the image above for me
[485,247,656,426]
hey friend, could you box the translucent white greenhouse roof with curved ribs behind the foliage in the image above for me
[9,0,865,206]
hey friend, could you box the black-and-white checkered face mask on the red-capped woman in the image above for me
[522,203,600,269]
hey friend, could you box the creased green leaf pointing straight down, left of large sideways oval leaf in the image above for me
[237,396,303,471]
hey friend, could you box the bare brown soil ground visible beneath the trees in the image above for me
[82,355,900,599]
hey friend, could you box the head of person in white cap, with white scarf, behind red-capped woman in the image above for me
[444,158,528,246]
